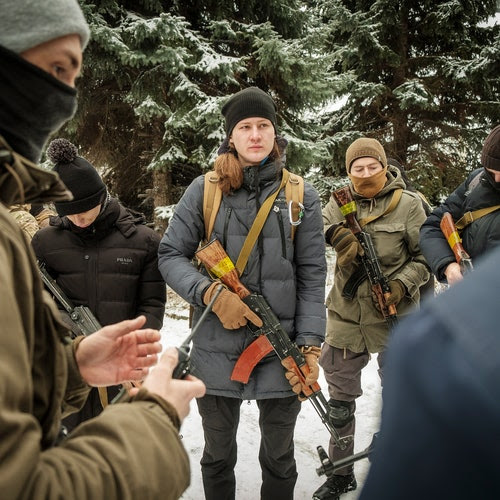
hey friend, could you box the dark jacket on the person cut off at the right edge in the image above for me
[420,168,500,283]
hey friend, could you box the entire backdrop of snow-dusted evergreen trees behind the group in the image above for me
[62,0,500,224]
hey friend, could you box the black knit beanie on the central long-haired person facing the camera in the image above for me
[222,87,276,137]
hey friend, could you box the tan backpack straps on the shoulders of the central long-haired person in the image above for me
[203,168,304,243]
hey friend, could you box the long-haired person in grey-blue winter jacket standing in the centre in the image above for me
[159,87,326,500]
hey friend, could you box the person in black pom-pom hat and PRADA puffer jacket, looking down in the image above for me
[32,139,166,431]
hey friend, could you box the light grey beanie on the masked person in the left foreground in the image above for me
[0,0,90,54]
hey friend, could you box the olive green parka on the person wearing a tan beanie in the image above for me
[323,166,430,353]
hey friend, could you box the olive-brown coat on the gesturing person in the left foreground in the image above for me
[0,137,189,500]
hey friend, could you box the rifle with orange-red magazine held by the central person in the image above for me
[196,236,352,450]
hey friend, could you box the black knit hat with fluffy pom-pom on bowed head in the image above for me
[47,139,106,217]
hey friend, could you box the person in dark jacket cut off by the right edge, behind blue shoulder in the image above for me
[420,125,500,285]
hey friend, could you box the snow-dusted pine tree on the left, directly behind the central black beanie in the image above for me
[64,0,329,229]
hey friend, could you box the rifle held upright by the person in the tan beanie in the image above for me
[332,186,397,328]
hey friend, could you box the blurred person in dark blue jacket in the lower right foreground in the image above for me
[360,249,500,500]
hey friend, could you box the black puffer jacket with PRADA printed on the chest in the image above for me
[32,199,166,329]
